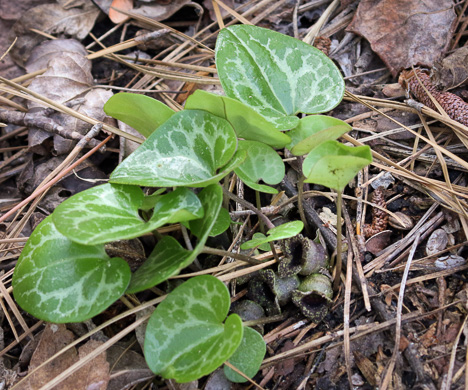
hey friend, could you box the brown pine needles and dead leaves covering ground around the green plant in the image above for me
[0,0,468,389]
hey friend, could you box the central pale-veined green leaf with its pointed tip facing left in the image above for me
[111,110,245,187]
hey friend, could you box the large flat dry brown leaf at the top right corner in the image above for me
[347,0,456,76]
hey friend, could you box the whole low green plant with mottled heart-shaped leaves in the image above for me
[12,25,362,382]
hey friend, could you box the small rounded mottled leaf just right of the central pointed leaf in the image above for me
[234,141,285,194]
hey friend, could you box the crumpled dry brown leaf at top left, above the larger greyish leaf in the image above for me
[10,0,99,66]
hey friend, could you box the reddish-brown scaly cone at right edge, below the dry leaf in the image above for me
[399,69,468,126]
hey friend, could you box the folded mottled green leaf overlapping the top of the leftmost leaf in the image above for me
[52,184,203,245]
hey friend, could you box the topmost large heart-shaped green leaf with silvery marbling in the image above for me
[216,25,344,129]
